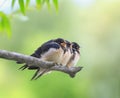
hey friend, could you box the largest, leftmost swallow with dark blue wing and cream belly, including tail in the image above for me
[17,38,66,80]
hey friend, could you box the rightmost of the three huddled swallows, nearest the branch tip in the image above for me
[66,42,80,68]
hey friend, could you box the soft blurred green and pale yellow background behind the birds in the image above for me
[0,0,120,98]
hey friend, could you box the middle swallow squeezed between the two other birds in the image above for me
[61,40,72,66]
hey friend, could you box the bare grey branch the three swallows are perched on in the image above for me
[0,50,82,77]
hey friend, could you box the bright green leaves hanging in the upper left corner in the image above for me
[0,0,58,36]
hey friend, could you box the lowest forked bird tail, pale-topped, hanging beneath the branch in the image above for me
[31,68,50,80]
